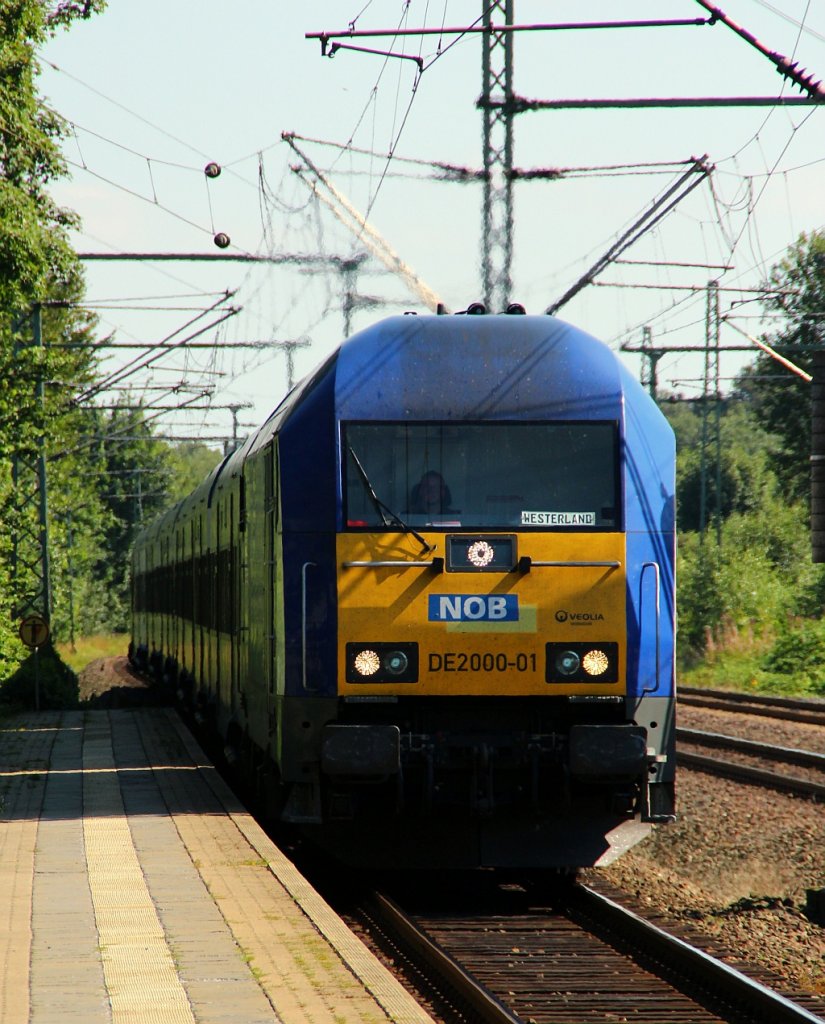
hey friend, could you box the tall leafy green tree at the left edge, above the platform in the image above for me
[0,0,104,674]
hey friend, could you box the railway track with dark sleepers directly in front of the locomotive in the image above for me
[343,884,823,1024]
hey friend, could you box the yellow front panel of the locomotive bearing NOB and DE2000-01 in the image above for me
[338,531,626,696]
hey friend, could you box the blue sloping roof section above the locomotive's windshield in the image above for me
[336,315,623,421]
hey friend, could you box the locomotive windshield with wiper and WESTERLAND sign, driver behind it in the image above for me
[342,422,620,530]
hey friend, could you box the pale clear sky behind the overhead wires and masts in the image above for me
[39,0,825,444]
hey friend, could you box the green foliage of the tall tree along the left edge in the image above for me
[0,0,113,679]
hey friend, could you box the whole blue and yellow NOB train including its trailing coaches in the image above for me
[132,314,675,868]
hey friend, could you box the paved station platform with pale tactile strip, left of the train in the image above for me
[0,709,440,1024]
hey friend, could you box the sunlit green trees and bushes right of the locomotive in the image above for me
[665,231,825,692]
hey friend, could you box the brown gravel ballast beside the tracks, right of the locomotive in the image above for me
[585,708,825,1010]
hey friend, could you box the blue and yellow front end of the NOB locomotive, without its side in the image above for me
[290,315,675,867]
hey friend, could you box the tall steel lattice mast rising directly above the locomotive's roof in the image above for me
[478,0,515,312]
